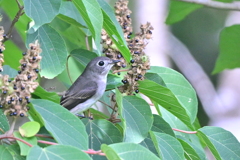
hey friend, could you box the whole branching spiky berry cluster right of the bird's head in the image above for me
[102,0,153,95]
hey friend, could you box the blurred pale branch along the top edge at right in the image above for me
[174,0,240,11]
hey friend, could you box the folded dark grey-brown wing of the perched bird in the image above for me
[61,81,98,110]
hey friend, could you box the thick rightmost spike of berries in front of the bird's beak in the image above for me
[119,22,153,95]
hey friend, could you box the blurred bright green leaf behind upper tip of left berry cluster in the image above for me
[3,40,22,70]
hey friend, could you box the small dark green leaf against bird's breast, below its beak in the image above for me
[106,74,122,90]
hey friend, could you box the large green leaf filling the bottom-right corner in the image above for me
[198,126,240,160]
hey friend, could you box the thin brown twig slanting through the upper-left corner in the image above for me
[2,0,24,43]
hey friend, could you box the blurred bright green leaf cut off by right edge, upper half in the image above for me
[213,25,240,74]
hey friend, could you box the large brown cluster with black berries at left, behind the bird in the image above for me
[0,41,42,117]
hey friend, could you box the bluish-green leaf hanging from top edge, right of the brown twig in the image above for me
[23,0,61,31]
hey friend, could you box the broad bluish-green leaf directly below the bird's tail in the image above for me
[32,99,88,150]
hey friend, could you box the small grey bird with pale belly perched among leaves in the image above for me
[60,57,119,114]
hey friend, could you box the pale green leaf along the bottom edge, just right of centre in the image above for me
[109,143,159,160]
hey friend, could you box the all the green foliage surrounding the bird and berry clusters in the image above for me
[0,0,240,160]
